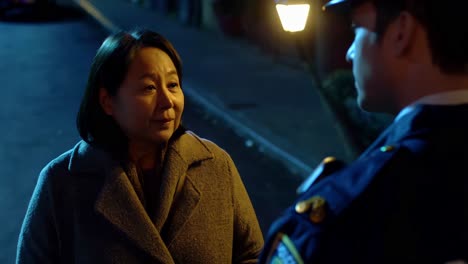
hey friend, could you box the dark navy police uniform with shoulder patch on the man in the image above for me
[259,0,468,264]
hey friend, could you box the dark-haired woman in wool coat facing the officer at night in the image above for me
[17,31,263,263]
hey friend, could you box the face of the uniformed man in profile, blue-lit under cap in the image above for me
[346,2,394,112]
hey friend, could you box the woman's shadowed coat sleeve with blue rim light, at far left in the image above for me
[16,166,59,264]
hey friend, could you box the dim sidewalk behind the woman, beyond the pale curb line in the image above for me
[74,0,352,177]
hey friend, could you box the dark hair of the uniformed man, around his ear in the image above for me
[357,0,468,73]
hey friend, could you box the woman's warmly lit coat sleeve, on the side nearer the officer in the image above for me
[228,156,263,263]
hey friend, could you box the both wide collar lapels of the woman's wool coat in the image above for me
[69,131,213,263]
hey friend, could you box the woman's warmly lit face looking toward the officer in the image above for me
[100,47,184,146]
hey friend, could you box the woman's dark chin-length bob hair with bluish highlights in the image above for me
[76,30,182,155]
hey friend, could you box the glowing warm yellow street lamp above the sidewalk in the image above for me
[276,4,310,32]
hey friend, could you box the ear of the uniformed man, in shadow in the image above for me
[390,11,417,56]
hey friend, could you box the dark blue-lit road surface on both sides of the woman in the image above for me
[0,5,300,263]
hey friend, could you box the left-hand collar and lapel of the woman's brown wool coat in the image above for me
[69,142,174,263]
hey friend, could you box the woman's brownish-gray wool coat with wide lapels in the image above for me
[17,132,263,264]
